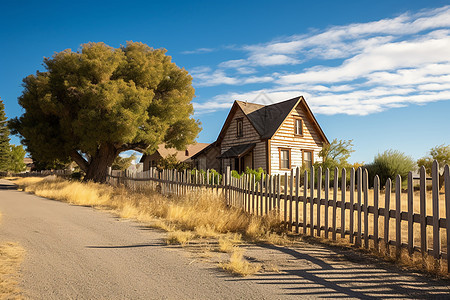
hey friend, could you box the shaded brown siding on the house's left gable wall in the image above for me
[220,109,266,171]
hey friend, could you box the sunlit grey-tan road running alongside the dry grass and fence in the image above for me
[0,181,450,299]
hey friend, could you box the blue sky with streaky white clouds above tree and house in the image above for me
[0,0,450,162]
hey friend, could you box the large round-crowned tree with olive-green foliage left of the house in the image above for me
[10,42,200,182]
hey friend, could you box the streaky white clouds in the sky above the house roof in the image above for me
[193,6,450,115]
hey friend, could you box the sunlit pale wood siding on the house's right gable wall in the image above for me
[270,104,322,174]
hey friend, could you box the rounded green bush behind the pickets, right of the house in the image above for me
[365,150,415,186]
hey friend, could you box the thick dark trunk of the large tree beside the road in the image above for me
[84,144,117,183]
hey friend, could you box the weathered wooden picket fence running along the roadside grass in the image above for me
[104,161,450,270]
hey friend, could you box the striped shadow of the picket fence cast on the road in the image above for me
[228,245,450,299]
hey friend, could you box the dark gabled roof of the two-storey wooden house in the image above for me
[217,96,329,144]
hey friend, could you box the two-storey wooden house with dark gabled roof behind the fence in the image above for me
[193,96,329,174]
